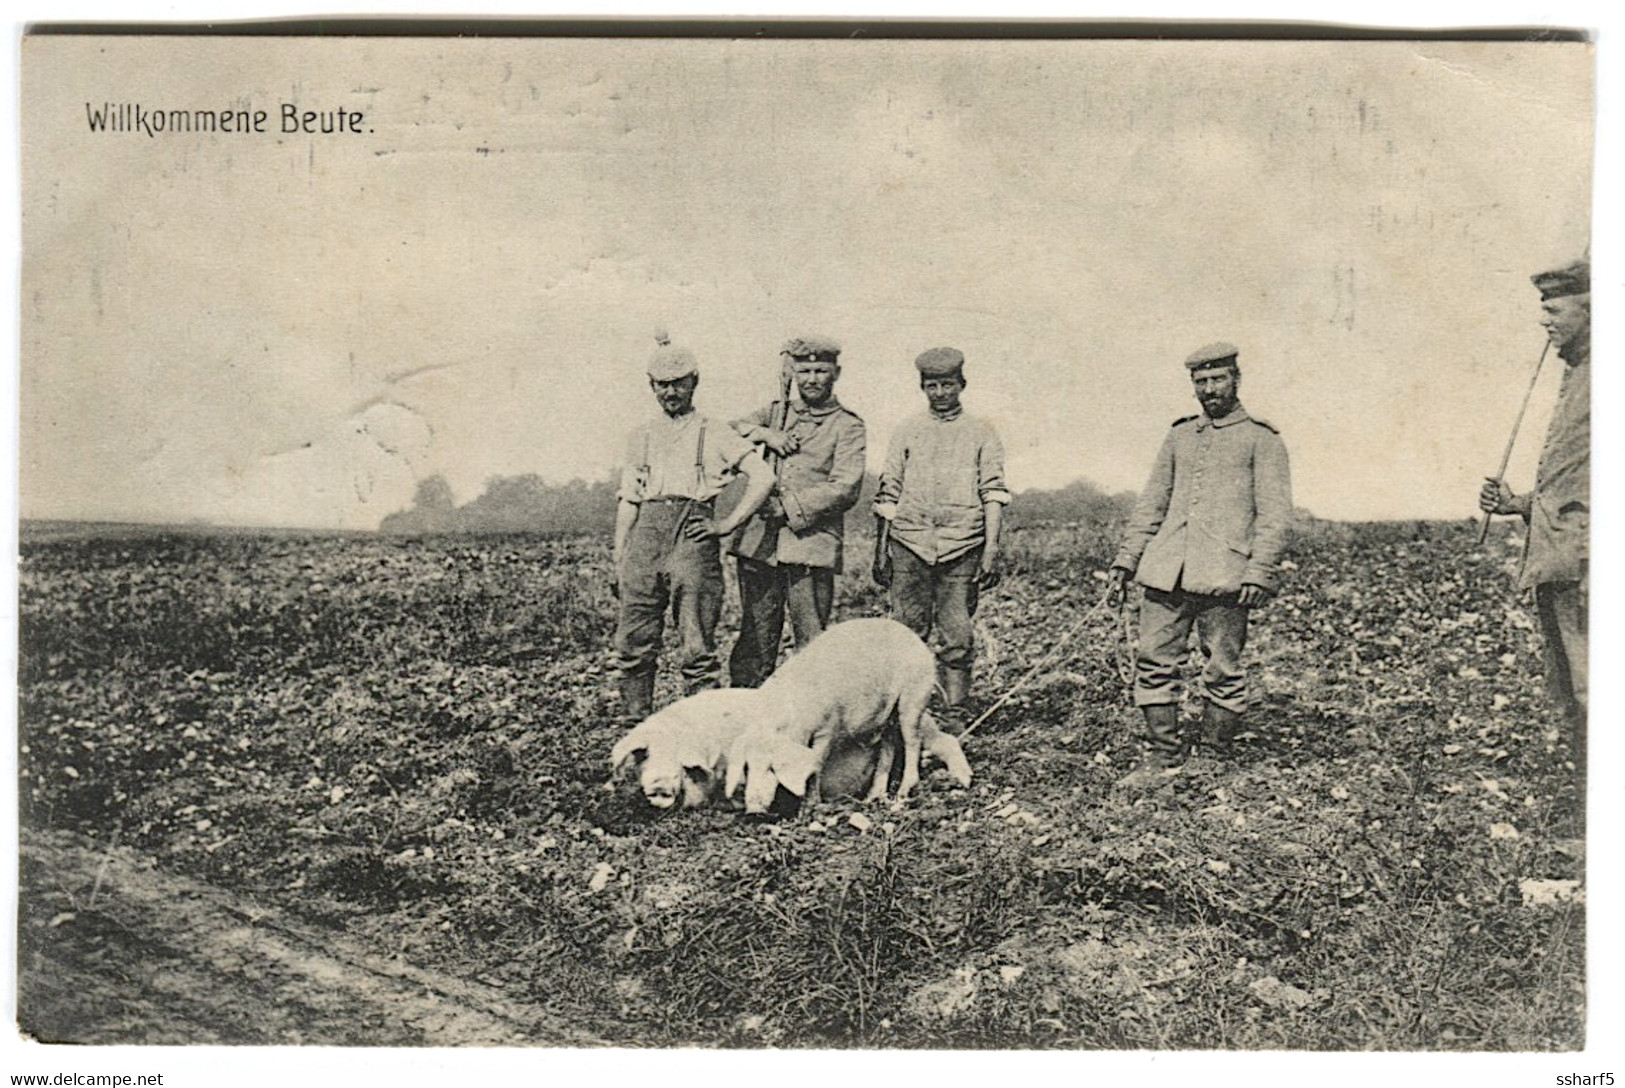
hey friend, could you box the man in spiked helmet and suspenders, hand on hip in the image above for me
[614,344,774,721]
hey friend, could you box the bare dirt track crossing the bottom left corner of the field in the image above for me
[18,830,595,1046]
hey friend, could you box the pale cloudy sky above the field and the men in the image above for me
[20,37,1593,528]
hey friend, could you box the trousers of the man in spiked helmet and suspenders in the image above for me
[614,499,723,693]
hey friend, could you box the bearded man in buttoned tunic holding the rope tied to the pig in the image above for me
[1108,343,1292,770]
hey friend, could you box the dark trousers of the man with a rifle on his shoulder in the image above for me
[728,555,835,687]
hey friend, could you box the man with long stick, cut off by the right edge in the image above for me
[1479,260,1591,781]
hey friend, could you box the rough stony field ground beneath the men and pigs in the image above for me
[18,520,1586,1051]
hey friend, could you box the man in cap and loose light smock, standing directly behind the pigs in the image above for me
[874,348,1011,732]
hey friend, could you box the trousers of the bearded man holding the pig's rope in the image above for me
[1134,586,1246,713]
